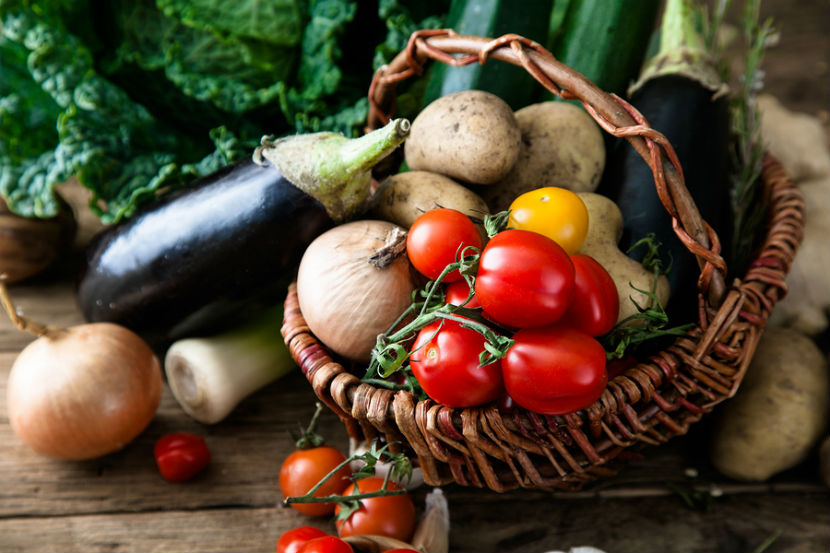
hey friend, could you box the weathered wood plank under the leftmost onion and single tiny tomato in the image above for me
[0,354,346,517]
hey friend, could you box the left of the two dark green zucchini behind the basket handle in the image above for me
[424,0,553,110]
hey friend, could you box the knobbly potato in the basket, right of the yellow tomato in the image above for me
[577,192,669,322]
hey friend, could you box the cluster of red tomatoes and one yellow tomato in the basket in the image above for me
[406,187,619,415]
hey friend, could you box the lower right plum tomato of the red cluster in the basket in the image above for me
[501,324,608,415]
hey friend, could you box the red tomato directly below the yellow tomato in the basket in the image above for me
[475,229,574,328]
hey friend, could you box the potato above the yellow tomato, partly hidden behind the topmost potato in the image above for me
[479,102,605,213]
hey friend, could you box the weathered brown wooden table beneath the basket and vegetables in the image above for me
[0,0,830,553]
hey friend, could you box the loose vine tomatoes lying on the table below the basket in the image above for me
[277,438,416,553]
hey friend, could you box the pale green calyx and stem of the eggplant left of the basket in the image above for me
[254,119,410,223]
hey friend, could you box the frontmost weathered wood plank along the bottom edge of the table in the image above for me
[0,487,830,553]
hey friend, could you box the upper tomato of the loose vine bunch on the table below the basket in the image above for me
[280,446,352,516]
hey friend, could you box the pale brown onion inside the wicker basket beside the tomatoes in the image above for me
[297,220,415,362]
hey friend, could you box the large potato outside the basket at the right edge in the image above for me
[711,328,830,481]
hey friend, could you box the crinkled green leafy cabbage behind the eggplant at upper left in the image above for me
[0,0,447,223]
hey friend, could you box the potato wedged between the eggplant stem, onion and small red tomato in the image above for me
[370,171,488,228]
